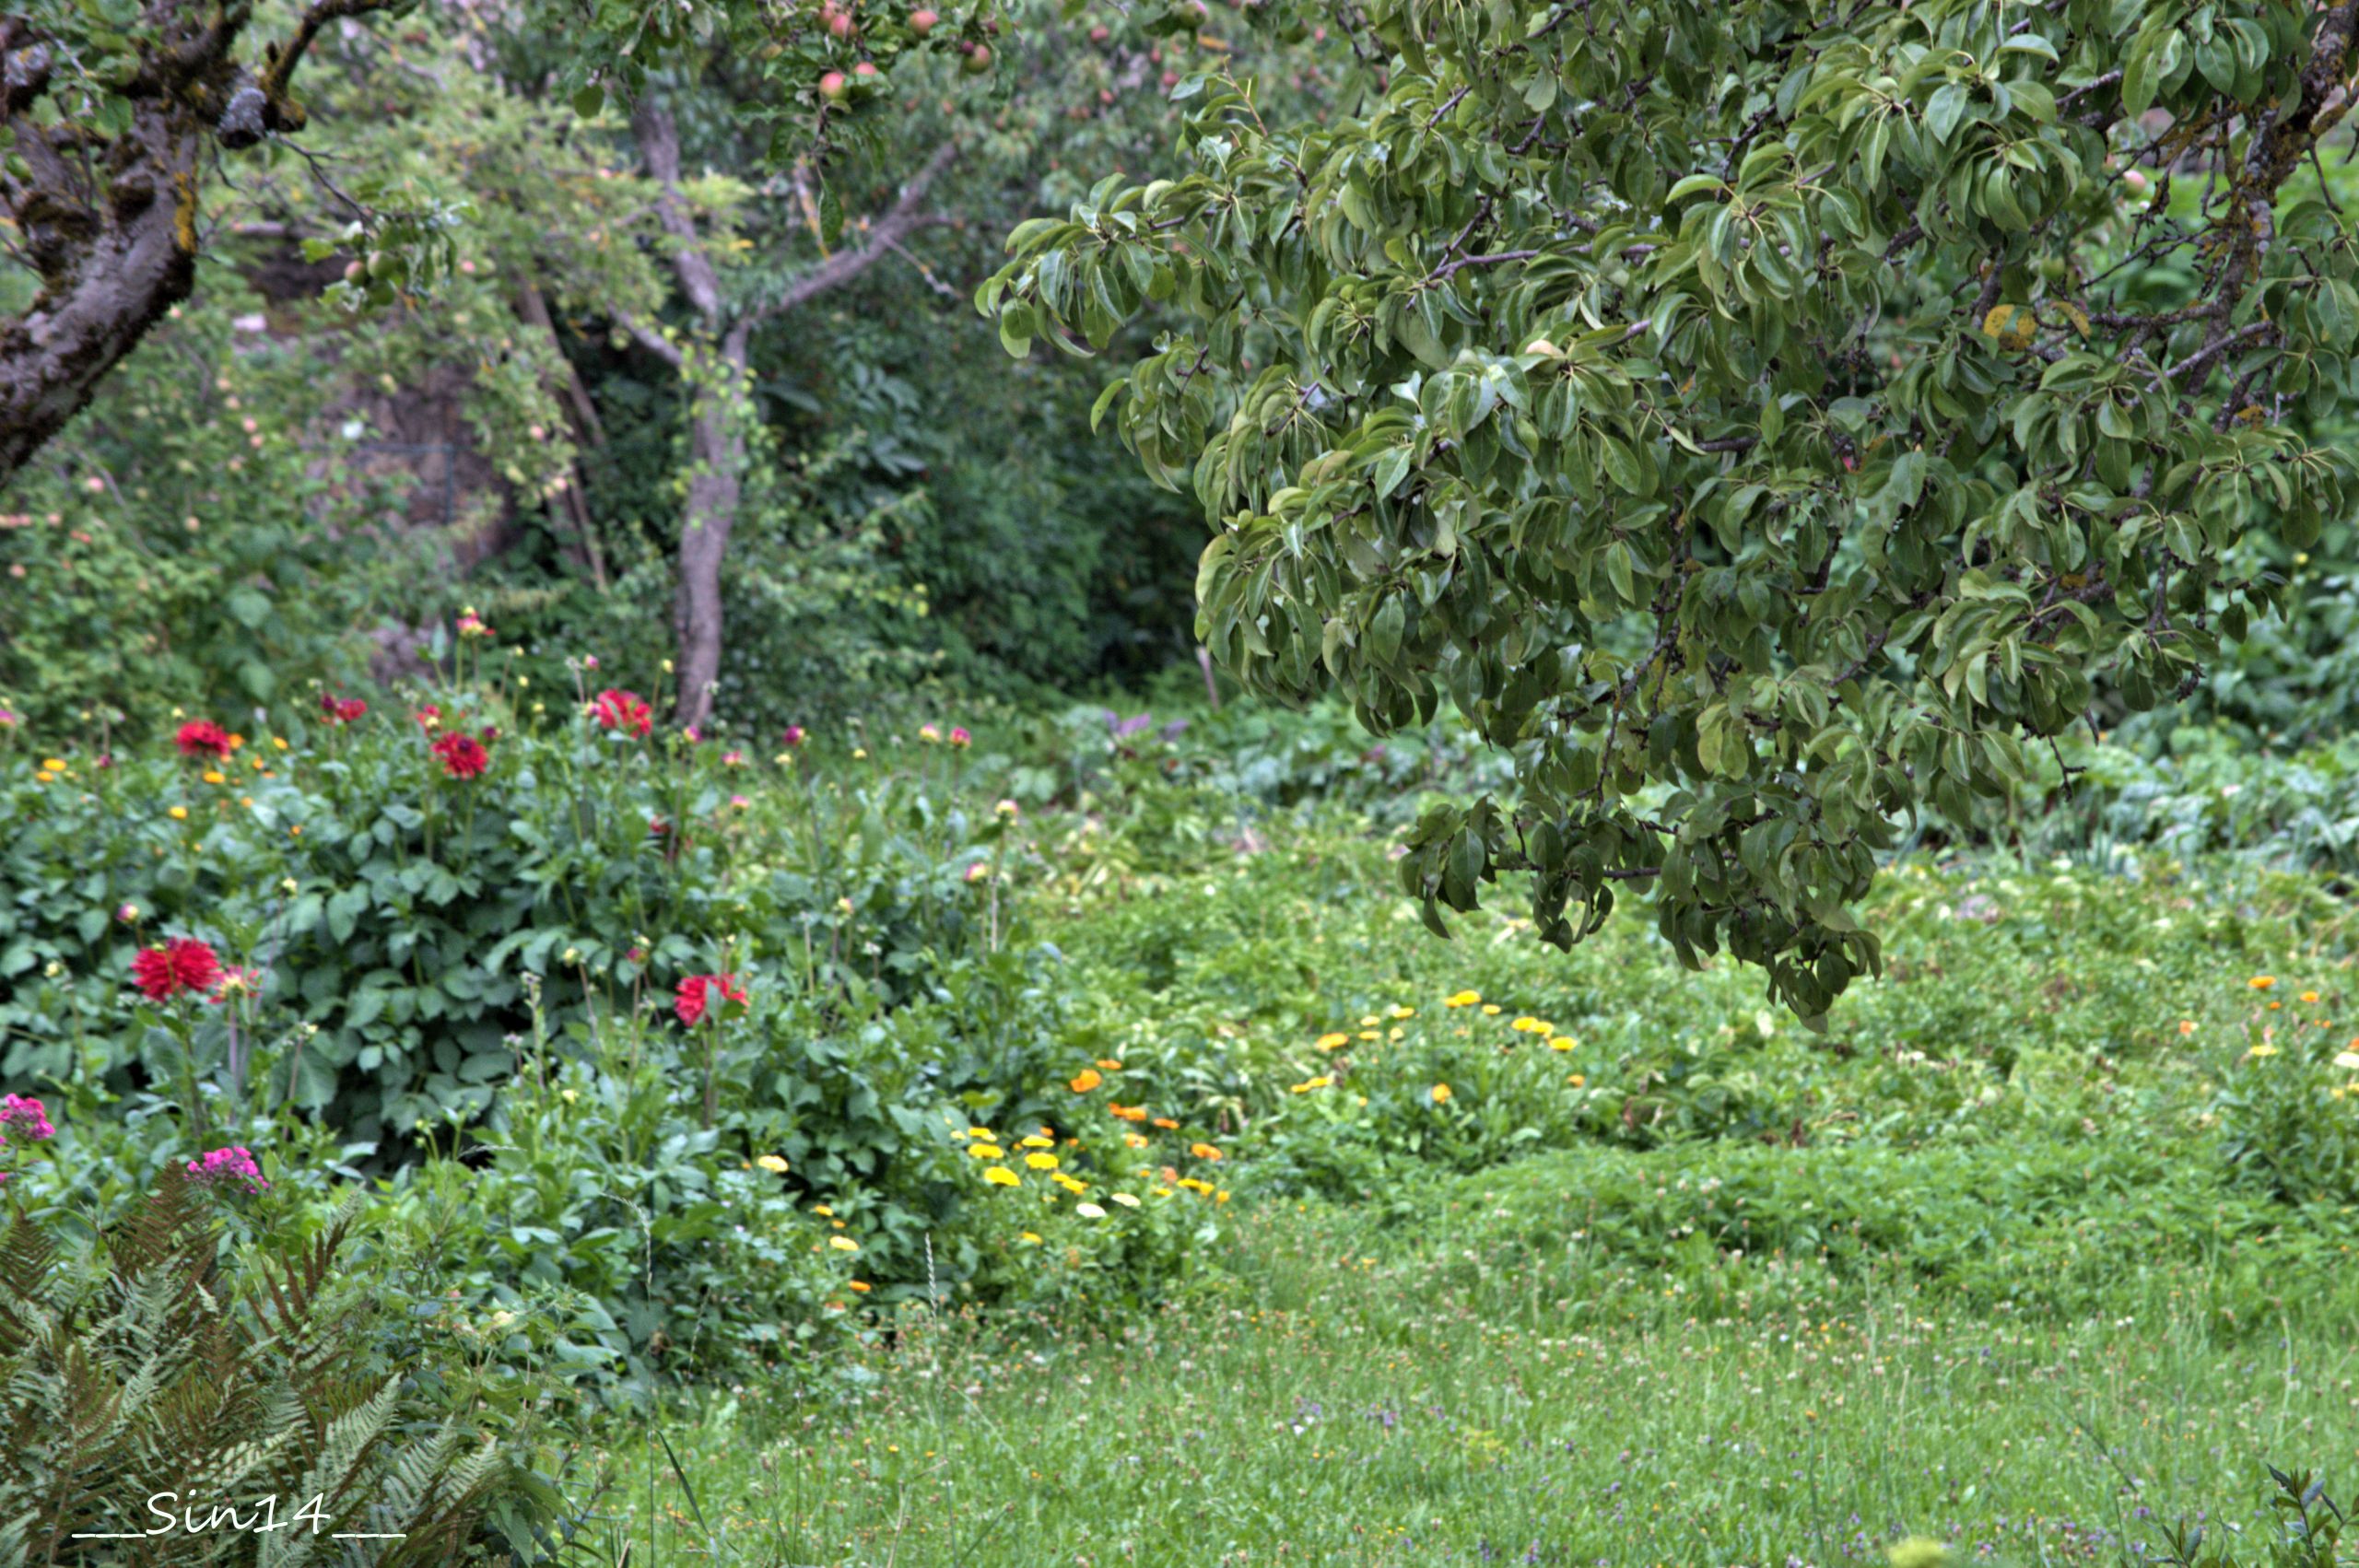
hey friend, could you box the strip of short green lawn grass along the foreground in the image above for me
[584,1193,2359,1568]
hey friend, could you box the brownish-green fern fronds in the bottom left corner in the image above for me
[0,1164,559,1568]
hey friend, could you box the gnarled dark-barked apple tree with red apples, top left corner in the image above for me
[0,0,957,495]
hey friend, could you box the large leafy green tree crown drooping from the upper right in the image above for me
[979,0,2359,1019]
